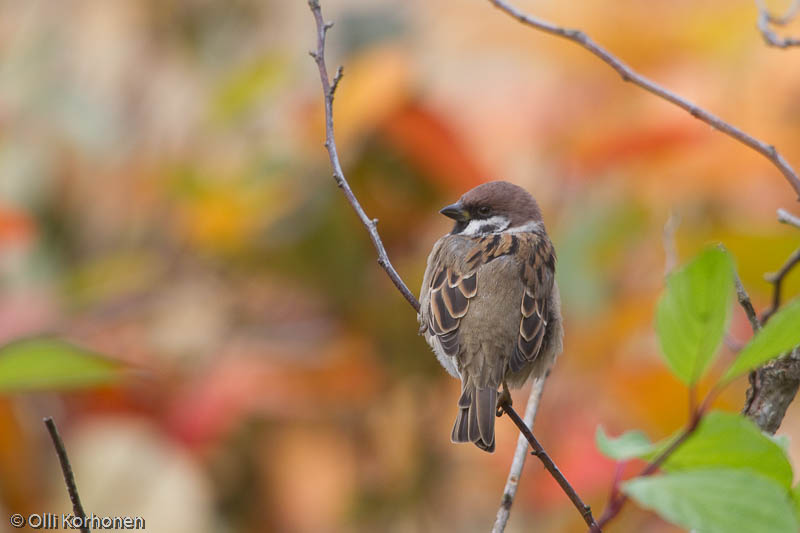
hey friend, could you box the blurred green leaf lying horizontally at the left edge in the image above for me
[0,338,122,391]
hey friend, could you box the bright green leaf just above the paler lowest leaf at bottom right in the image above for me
[662,411,792,489]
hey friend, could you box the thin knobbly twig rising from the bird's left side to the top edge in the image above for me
[308,0,419,312]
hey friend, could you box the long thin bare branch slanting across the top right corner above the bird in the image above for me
[489,0,800,200]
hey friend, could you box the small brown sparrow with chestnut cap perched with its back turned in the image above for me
[418,181,563,452]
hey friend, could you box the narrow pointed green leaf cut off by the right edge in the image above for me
[722,298,800,381]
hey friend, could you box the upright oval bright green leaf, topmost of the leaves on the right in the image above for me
[656,248,733,385]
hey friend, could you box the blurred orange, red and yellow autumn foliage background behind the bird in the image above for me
[0,0,800,533]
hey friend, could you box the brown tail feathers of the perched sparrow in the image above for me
[450,383,497,453]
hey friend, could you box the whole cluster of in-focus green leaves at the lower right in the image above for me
[596,248,800,533]
